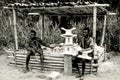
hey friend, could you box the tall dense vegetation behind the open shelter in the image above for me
[0,0,120,51]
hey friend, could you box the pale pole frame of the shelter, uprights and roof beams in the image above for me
[4,3,109,75]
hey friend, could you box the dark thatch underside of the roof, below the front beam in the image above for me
[41,6,106,15]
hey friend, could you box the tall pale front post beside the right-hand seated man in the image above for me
[90,6,97,73]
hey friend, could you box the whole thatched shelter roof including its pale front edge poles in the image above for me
[4,4,107,15]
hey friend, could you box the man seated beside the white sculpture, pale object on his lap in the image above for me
[73,28,93,77]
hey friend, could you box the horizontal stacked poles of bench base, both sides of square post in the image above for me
[8,51,97,73]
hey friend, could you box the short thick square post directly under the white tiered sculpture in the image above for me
[64,54,72,76]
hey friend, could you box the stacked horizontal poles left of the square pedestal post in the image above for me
[8,50,64,71]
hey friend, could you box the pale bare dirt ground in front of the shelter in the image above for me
[0,52,120,80]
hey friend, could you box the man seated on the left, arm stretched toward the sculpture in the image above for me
[26,30,53,71]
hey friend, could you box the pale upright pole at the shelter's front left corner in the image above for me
[13,8,18,50]
